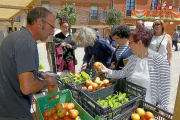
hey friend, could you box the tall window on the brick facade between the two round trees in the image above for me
[91,3,98,20]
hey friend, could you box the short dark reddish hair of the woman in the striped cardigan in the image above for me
[129,27,153,47]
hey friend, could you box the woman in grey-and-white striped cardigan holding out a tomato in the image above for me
[96,27,171,110]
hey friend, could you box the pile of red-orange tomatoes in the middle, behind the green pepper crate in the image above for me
[82,77,112,92]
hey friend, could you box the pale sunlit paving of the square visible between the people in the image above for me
[32,43,180,115]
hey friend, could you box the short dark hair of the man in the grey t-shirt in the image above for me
[27,7,53,25]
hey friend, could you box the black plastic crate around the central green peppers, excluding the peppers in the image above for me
[80,79,146,120]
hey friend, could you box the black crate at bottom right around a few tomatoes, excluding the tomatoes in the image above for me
[120,100,173,120]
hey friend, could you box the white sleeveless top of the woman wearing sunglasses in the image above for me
[149,34,168,59]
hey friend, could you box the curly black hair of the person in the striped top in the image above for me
[112,25,131,38]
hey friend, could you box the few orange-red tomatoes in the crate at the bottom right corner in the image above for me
[131,108,155,120]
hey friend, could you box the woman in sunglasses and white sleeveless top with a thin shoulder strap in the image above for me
[149,20,172,66]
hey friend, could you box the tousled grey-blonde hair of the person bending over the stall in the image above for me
[72,27,97,47]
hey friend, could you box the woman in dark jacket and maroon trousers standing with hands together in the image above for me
[54,17,77,74]
